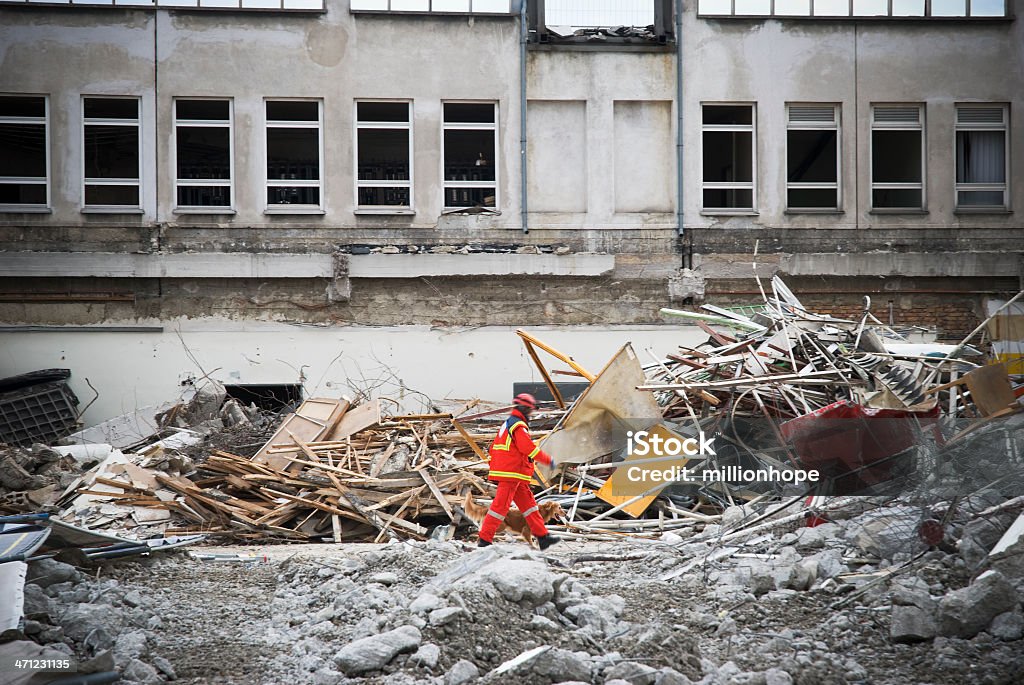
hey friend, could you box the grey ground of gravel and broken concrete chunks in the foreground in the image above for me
[72,540,1024,685]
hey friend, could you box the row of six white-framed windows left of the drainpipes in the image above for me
[0,95,498,212]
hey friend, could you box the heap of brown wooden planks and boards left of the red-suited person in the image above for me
[119,398,536,542]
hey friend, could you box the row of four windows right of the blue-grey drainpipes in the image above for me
[701,103,1010,212]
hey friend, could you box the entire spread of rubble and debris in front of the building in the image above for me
[0,279,1024,685]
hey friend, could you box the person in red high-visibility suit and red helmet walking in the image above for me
[477,392,560,550]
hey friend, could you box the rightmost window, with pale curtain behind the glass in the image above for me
[956,104,1010,209]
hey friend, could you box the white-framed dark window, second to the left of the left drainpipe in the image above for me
[355,101,413,209]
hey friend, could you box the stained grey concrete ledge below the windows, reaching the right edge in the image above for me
[778,252,1021,277]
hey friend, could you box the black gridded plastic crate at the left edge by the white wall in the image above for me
[0,381,78,446]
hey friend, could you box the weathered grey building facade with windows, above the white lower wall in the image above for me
[0,0,1024,417]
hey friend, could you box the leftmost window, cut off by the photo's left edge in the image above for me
[0,95,50,211]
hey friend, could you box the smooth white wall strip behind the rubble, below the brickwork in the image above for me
[0,319,707,425]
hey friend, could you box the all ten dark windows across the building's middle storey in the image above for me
[0,95,1010,213]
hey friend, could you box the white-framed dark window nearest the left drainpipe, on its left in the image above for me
[443,102,498,209]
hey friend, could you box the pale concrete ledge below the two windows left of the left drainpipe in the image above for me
[348,253,615,279]
